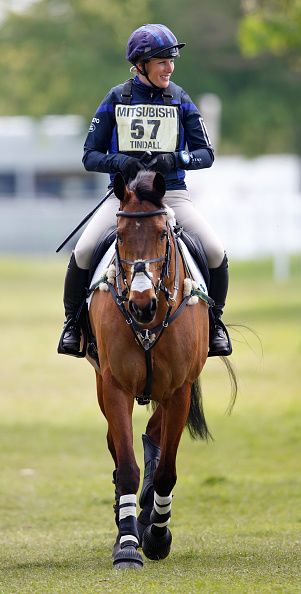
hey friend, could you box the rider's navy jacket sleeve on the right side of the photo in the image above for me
[181,91,214,170]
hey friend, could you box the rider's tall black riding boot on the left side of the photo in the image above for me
[58,253,89,357]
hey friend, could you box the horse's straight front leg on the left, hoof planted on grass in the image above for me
[103,371,143,569]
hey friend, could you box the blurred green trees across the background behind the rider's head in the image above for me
[0,0,301,155]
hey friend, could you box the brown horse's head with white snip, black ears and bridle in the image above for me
[114,171,170,324]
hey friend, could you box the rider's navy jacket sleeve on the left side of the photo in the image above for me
[83,91,127,173]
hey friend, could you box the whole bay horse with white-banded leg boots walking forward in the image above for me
[89,171,219,569]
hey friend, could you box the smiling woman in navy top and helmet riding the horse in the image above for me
[59,24,232,356]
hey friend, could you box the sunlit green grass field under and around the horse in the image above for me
[0,258,301,594]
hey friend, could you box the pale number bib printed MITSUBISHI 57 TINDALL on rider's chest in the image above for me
[115,104,179,153]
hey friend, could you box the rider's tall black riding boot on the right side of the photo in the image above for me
[208,254,232,357]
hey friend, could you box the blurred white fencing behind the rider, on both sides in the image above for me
[0,155,301,264]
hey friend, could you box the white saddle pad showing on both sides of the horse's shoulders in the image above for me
[87,238,208,309]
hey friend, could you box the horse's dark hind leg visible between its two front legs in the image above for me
[137,405,162,542]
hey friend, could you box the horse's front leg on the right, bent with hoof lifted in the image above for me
[142,383,191,559]
